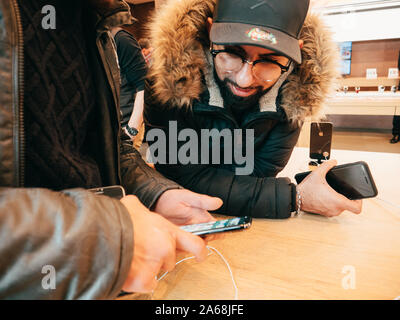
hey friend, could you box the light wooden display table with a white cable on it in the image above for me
[125,148,400,300]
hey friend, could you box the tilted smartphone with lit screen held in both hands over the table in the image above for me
[181,216,252,236]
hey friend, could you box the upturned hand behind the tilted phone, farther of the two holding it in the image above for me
[154,189,222,225]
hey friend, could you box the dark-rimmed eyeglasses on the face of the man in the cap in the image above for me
[210,47,291,82]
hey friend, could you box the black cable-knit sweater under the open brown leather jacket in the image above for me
[19,0,101,190]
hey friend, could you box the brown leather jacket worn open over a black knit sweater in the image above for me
[0,0,180,299]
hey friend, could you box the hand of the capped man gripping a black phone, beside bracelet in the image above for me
[297,160,362,217]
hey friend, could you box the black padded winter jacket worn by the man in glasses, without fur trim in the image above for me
[145,74,301,218]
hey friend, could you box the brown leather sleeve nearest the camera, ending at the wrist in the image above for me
[0,188,133,299]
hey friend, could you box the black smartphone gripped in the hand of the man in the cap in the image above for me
[295,161,378,200]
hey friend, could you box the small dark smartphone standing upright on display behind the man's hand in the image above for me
[310,122,333,160]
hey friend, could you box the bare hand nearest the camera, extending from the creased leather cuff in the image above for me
[121,195,208,293]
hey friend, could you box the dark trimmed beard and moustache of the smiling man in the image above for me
[214,68,271,112]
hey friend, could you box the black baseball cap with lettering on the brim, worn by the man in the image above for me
[210,0,310,63]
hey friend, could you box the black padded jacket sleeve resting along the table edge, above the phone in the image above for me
[156,164,295,219]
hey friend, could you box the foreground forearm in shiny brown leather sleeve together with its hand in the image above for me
[0,188,207,299]
